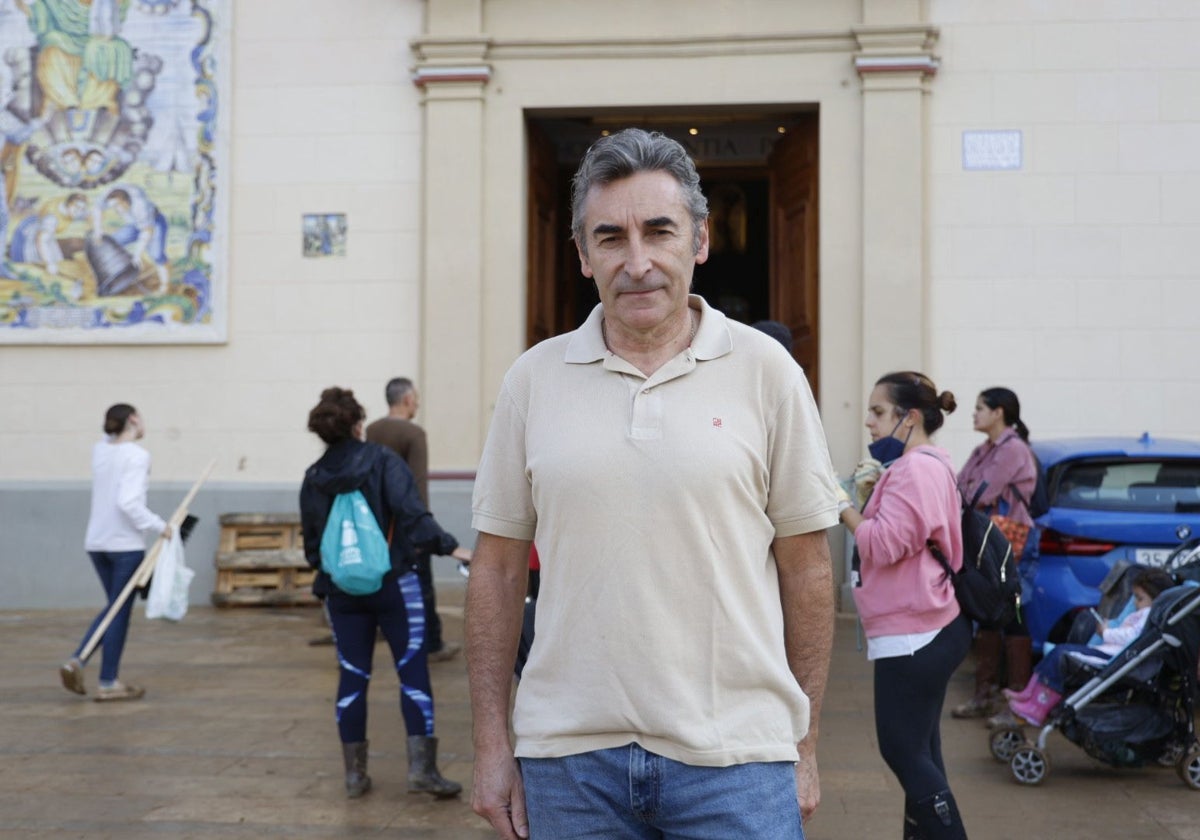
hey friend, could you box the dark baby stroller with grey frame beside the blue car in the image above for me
[990,547,1200,790]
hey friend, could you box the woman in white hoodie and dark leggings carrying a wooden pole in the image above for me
[59,403,170,701]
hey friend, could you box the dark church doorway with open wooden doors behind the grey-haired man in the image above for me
[527,109,818,394]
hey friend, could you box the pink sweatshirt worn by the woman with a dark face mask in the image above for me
[854,445,962,638]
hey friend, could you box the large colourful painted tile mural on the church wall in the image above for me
[0,0,228,343]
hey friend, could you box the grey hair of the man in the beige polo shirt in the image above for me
[571,128,708,254]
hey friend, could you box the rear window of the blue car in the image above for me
[1051,460,1200,512]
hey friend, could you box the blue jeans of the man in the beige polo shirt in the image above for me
[520,744,804,840]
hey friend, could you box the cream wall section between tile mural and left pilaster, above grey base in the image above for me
[0,0,429,482]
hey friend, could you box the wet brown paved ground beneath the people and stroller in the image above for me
[0,584,1200,840]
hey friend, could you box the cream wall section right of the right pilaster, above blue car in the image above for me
[929,0,1200,465]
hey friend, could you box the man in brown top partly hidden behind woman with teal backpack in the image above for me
[367,377,462,662]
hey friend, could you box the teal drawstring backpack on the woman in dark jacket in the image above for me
[320,490,391,595]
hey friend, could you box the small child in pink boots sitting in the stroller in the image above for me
[1004,568,1175,726]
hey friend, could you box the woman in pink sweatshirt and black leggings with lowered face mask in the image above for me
[840,372,971,840]
